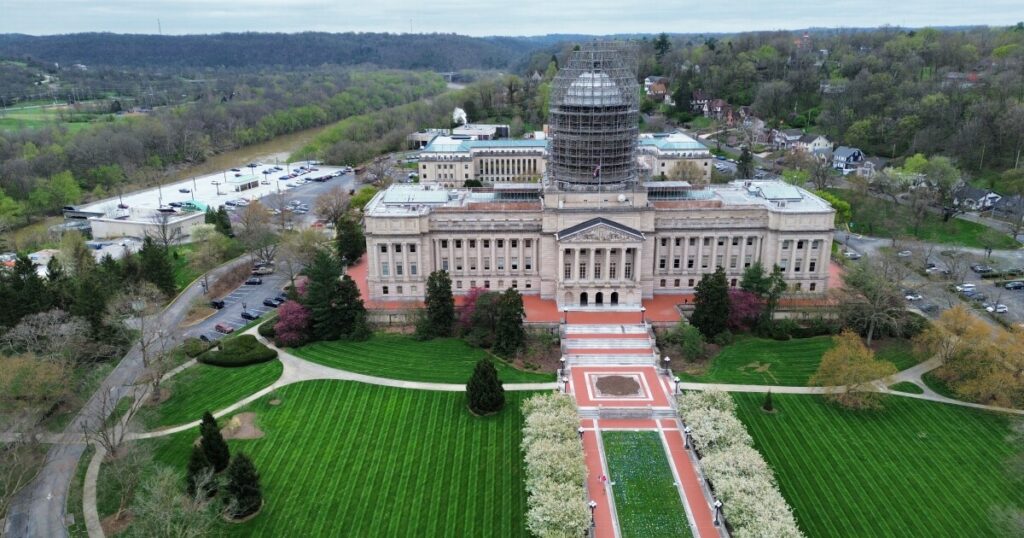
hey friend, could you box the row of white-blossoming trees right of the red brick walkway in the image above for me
[677,390,803,538]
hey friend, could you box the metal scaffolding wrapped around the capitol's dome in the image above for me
[548,42,640,191]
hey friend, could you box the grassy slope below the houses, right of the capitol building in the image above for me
[828,189,1020,249]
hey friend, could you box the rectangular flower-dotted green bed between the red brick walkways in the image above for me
[601,431,692,538]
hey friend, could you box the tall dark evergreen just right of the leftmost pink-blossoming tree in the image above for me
[302,250,348,340]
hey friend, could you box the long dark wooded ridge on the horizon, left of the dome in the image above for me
[0,32,544,71]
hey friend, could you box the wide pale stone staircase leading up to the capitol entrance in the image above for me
[561,323,656,367]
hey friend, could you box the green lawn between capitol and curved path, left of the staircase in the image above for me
[291,333,554,383]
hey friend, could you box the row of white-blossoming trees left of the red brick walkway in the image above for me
[522,392,590,538]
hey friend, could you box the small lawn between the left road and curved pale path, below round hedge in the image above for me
[143,359,283,427]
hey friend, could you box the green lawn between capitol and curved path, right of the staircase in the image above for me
[681,336,920,386]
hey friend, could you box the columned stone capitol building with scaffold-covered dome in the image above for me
[365,43,835,308]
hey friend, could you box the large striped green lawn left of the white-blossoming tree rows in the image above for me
[155,381,529,537]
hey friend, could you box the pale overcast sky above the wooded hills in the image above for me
[0,0,1024,36]
